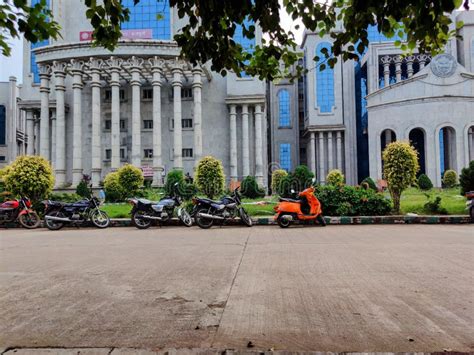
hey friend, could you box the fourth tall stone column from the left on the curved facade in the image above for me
[89,58,103,187]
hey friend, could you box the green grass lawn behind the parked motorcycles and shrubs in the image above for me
[102,188,467,218]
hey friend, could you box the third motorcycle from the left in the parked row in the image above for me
[129,183,193,229]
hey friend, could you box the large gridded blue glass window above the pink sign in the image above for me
[122,0,171,40]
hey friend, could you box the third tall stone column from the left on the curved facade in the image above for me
[70,59,84,186]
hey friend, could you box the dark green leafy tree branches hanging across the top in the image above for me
[0,0,469,80]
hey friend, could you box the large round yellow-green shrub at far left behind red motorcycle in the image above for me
[3,155,54,202]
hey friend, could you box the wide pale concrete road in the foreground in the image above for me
[0,225,474,351]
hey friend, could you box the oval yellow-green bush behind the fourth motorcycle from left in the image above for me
[194,156,225,199]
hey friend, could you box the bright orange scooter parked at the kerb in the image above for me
[274,186,326,228]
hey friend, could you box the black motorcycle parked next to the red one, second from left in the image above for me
[43,197,110,230]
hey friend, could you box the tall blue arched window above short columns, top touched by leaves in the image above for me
[315,42,334,112]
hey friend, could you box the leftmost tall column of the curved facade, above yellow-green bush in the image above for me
[39,64,50,160]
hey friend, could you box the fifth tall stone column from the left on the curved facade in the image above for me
[107,57,123,170]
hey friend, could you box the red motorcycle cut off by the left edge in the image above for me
[0,197,40,229]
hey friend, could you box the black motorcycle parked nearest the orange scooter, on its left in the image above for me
[192,188,252,229]
